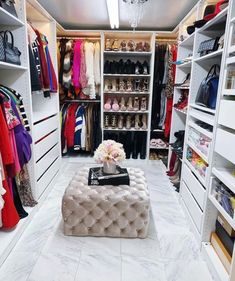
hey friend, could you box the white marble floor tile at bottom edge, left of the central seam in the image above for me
[75,252,121,281]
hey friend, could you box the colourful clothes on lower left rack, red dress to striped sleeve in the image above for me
[0,85,37,228]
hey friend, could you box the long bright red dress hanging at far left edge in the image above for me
[0,107,20,228]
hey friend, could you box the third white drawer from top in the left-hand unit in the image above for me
[36,144,60,179]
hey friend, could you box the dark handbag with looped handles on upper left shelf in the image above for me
[0,30,21,65]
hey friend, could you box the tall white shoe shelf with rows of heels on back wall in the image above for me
[101,31,155,159]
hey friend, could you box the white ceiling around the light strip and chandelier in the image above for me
[36,0,198,30]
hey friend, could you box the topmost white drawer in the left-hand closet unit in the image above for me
[34,115,59,142]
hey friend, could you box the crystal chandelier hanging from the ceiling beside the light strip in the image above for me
[123,0,148,29]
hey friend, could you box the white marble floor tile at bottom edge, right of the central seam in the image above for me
[122,256,167,281]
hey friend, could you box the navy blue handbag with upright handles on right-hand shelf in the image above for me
[195,64,220,109]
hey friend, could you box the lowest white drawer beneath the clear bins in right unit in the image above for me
[181,182,203,232]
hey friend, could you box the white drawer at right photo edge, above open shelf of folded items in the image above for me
[215,129,235,164]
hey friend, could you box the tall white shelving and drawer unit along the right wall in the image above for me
[179,0,235,281]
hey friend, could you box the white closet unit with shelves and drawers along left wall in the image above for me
[0,0,61,265]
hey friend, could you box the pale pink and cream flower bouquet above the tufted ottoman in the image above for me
[94,140,126,163]
